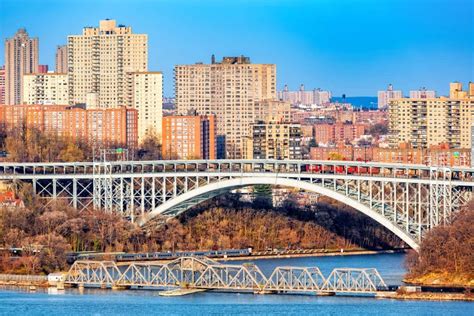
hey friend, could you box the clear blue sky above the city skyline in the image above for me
[0,0,474,96]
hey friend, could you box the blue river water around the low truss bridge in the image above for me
[0,254,468,316]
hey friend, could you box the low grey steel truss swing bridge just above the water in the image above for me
[64,257,388,295]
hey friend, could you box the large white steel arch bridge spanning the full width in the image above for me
[0,160,474,249]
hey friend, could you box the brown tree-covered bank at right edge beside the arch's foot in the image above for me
[406,200,474,286]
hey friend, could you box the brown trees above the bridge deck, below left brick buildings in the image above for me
[0,126,161,162]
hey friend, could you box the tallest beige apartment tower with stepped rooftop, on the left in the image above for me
[67,20,148,108]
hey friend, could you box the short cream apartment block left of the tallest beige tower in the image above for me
[23,73,69,105]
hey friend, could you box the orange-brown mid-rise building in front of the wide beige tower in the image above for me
[161,115,217,159]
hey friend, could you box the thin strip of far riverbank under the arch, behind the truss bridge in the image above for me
[220,249,406,261]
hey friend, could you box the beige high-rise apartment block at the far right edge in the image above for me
[389,83,474,148]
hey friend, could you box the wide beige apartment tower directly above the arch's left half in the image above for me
[175,56,276,158]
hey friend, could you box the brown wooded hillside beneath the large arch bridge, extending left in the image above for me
[0,187,402,273]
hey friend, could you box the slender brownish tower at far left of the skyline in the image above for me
[5,29,39,105]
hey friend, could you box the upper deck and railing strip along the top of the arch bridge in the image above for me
[0,159,474,181]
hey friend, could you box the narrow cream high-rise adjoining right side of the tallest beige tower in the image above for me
[125,72,163,141]
